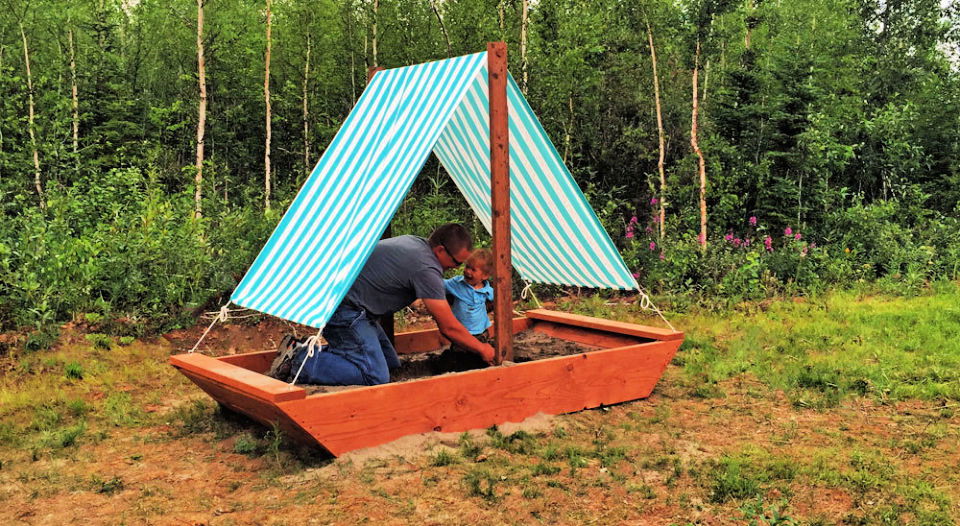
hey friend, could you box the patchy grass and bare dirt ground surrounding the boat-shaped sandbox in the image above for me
[0,285,960,525]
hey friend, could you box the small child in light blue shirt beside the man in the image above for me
[441,248,493,371]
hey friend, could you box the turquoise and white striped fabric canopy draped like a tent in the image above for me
[231,52,638,327]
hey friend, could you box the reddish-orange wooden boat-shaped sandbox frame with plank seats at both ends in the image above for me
[170,309,683,456]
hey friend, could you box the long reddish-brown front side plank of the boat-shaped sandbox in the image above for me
[279,341,681,455]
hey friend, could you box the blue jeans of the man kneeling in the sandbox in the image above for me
[292,304,400,385]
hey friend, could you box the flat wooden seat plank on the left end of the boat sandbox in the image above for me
[170,353,307,402]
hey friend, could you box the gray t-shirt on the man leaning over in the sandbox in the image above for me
[344,236,446,316]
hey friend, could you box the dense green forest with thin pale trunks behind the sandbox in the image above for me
[0,0,960,347]
